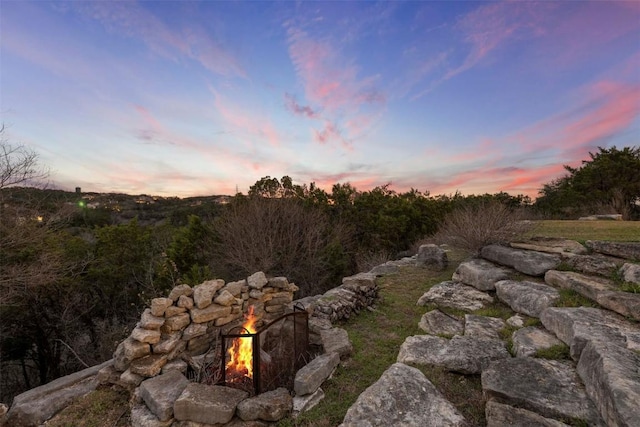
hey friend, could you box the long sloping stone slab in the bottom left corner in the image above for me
[4,360,113,427]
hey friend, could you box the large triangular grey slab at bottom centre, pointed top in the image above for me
[340,363,468,427]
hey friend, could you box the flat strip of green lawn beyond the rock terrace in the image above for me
[528,220,640,244]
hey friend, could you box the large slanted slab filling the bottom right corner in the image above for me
[578,340,640,427]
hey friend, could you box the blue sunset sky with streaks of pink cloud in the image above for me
[0,0,640,199]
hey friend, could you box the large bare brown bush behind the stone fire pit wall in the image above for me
[214,197,353,297]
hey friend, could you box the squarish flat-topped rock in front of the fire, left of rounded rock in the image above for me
[173,383,249,425]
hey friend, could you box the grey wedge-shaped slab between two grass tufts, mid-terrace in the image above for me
[496,280,560,317]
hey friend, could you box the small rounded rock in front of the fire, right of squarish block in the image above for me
[236,388,293,421]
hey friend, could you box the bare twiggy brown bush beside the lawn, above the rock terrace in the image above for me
[433,201,533,253]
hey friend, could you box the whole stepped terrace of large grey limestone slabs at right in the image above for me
[342,239,640,427]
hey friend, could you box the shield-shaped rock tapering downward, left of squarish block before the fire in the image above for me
[139,371,190,421]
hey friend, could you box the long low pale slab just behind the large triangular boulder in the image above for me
[397,335,511,374]
